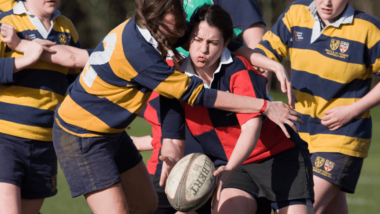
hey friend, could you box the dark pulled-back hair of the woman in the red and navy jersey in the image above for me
[190,4,234,44]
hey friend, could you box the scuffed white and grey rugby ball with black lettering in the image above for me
[166,153,217,212]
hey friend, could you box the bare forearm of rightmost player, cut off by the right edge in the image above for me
[351,83,380,116]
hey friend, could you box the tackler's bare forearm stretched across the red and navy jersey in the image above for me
[213,91,264,113]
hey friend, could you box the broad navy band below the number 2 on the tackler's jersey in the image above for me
[69,81,137,129]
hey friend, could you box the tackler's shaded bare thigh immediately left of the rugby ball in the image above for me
[120,161,158,213]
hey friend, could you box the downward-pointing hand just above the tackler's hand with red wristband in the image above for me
[273,63,297,109]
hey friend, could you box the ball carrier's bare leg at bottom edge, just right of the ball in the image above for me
[212,188,257,214]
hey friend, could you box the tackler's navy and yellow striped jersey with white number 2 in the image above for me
[56,18,216,137]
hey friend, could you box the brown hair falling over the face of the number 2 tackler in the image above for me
[135,0,186,70]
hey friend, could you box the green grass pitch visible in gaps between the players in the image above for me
[41,94,380,214]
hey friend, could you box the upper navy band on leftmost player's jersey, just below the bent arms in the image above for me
[12,69,67,96]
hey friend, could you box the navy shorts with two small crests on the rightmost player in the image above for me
[310,152,363,193]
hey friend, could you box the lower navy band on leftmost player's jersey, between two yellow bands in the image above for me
[0,102,54,128]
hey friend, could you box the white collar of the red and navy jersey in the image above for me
[180,48,233,88]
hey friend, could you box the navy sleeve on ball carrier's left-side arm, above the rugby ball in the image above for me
[160,96,185,140]
